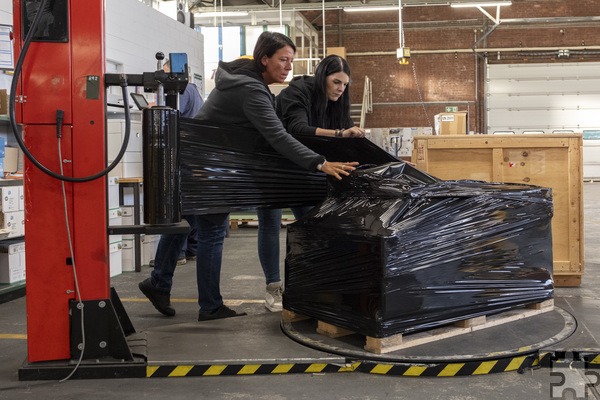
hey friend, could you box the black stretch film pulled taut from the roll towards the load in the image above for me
[180,118,398,215]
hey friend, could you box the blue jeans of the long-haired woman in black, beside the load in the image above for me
[256,207,312,285]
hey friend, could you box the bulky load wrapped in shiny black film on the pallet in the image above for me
[283,163,553,338]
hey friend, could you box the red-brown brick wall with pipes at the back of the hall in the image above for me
[303,0,600,133]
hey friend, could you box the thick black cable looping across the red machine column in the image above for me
[9,0,131,182]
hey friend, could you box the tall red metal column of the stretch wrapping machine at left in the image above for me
[13,0,110,362]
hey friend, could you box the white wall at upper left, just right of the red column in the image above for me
[109,0,205,96]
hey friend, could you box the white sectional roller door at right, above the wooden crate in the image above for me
[486,62,600,133]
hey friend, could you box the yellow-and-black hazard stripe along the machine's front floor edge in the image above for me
[146,352,600,378]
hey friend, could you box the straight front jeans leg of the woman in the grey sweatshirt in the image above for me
[196,213,229,313]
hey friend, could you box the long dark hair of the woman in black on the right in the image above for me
[310,55,353,129]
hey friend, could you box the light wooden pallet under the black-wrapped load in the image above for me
[282,299,554,354]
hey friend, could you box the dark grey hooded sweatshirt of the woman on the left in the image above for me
[196,59,325,171]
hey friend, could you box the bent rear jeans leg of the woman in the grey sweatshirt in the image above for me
[150,215,197,293]
